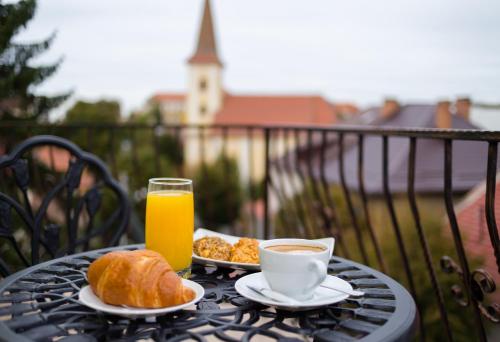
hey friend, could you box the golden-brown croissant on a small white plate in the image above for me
[87,250,195,308]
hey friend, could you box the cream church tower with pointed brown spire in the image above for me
[186,0,224,124]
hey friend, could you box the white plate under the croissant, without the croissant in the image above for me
[78,279,205,318]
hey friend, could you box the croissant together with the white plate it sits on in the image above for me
[79,249,205,318]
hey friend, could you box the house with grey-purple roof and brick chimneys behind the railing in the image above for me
[304,99,496,194]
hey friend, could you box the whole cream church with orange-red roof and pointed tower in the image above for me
[143,0,358,179]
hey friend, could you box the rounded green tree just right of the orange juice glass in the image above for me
[194,155,243,228]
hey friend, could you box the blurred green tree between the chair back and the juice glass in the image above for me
[59,99,183,235]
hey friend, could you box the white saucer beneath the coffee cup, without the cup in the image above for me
[234,272,352,311]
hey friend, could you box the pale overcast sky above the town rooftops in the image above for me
[10,0,500,129]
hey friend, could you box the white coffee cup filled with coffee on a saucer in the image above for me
[259,239,330,300]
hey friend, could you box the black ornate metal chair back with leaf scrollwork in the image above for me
[0,135,130,276]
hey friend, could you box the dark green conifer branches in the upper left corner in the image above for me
[0,0,70,120]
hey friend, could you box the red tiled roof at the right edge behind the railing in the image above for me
[455,174,500,301]
